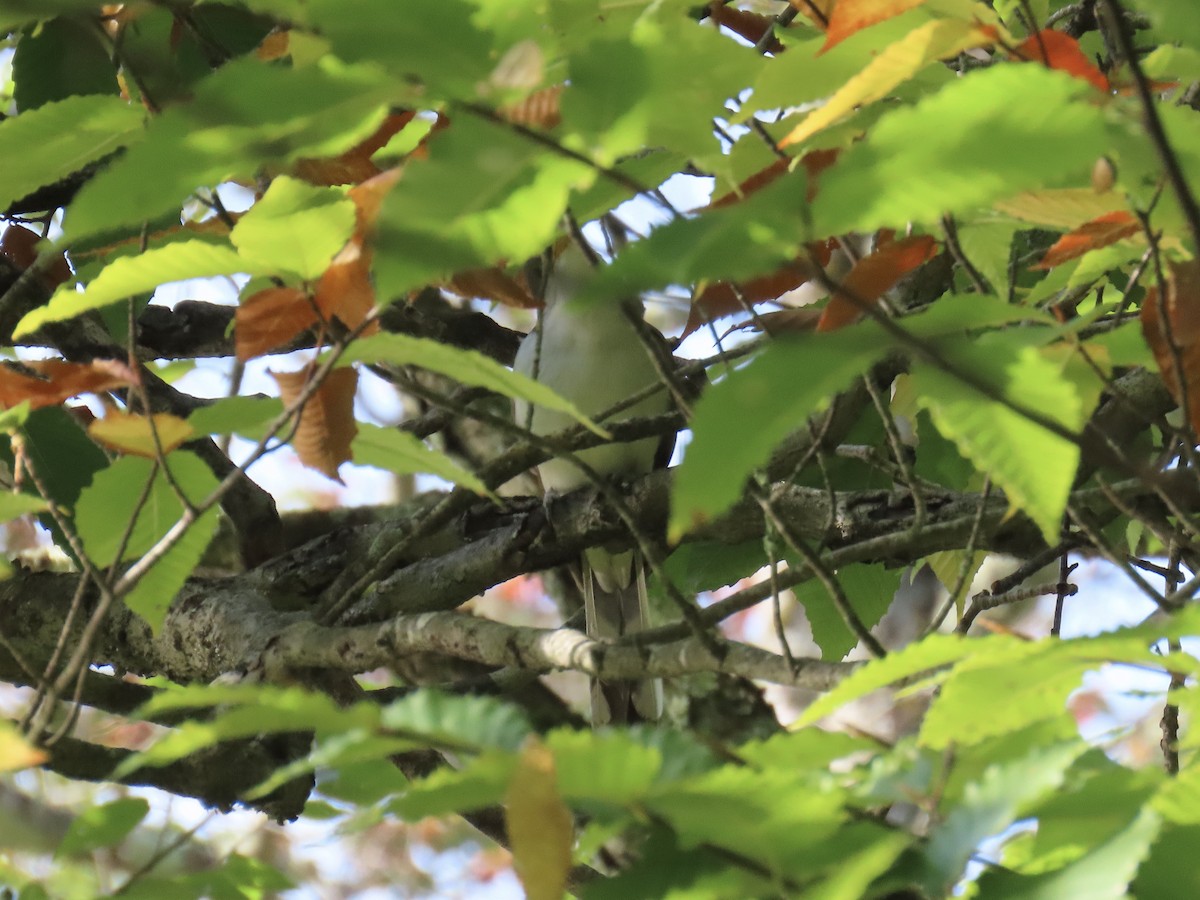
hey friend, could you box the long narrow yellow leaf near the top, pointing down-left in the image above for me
[779,19,994,146]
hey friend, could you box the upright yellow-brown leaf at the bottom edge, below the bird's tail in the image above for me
[504,737,575,900]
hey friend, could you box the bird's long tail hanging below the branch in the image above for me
[582,550,662,727]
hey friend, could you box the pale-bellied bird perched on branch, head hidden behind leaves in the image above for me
[514,242,673,727]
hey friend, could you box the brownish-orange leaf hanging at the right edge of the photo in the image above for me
[1141,259,1200,432]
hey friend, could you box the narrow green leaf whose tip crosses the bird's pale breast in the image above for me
[338,335,607,436]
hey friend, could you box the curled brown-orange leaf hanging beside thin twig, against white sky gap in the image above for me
[271,368,359,484]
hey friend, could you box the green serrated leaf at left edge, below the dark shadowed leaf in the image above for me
[0,96,143,209]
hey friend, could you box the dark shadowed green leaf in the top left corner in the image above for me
[12,18,120,113]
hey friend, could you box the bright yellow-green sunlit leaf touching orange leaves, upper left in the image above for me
[229,175,355,280]
